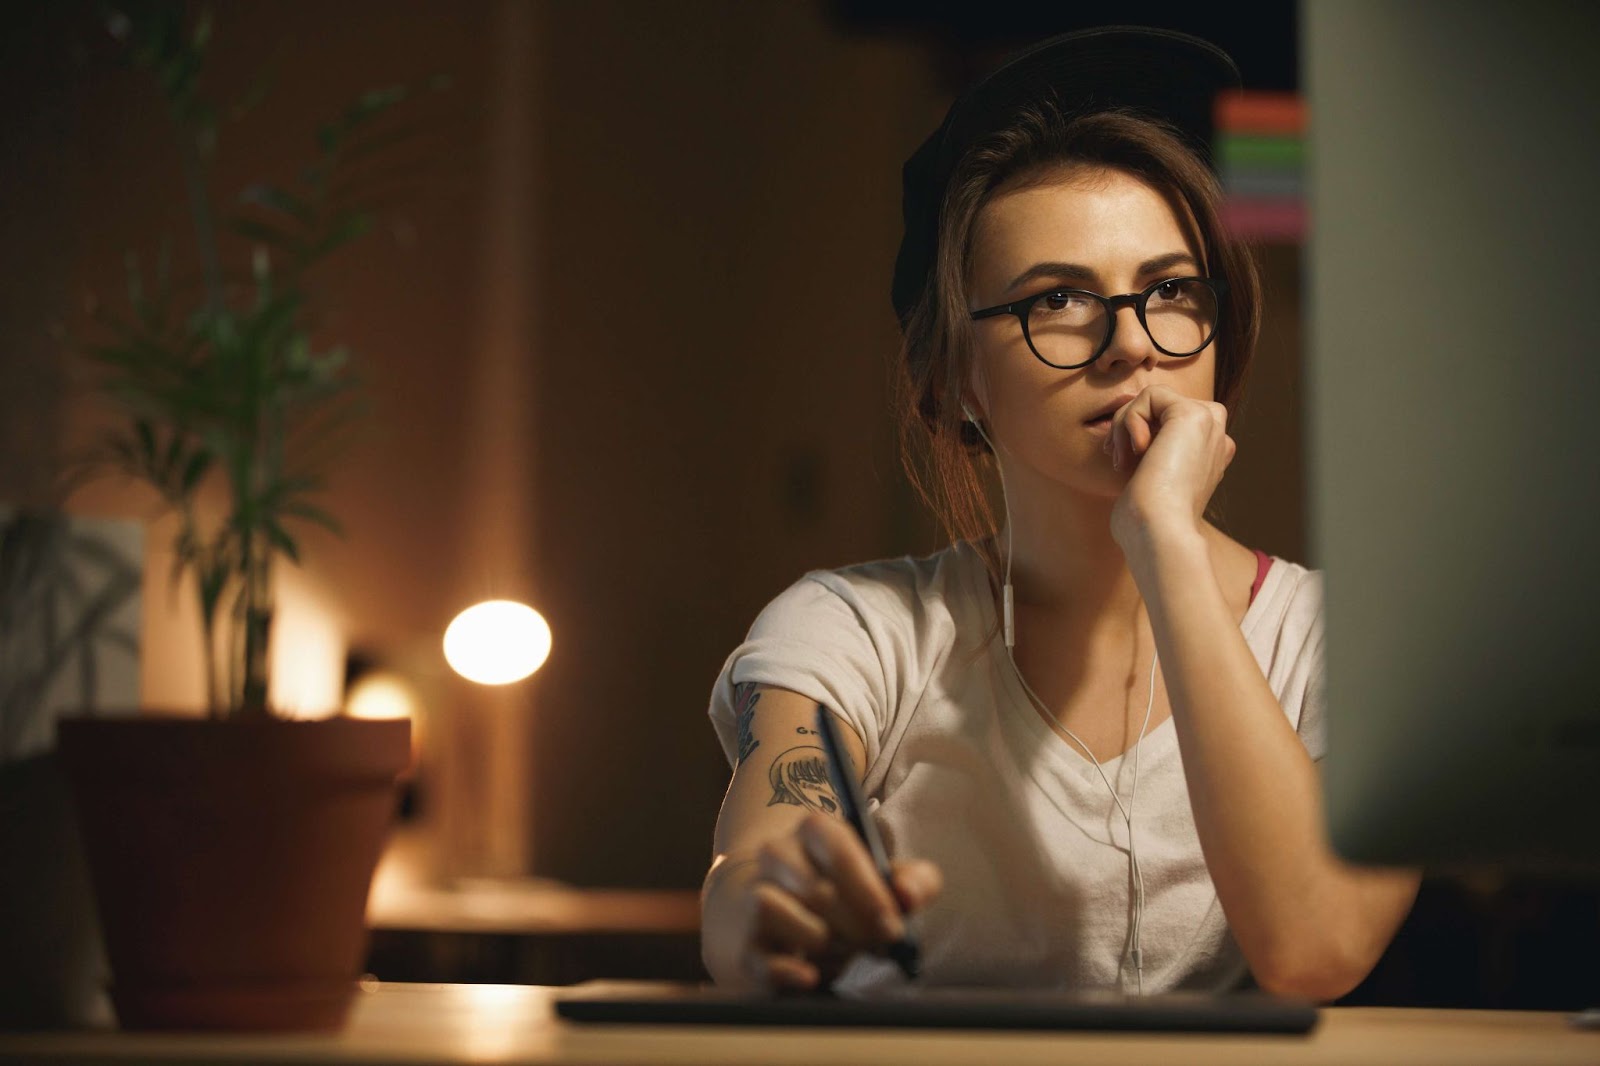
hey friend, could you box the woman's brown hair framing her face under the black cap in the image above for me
[894,102,1261,586]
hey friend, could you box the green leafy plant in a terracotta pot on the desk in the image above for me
[59,3,432,1029]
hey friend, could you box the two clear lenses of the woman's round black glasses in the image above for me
[1027,280,1216,367]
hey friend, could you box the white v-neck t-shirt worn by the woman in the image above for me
[710,543,1326,992]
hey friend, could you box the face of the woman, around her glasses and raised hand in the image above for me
[968,166,1216,498]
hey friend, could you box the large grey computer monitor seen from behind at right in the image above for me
[1301,0,1600,880]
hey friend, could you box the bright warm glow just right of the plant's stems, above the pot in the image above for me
[267,567,346,719]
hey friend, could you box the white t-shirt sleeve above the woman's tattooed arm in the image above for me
[710,571,890,773]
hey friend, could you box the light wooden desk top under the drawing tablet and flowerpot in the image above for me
[0,984,1600,1066]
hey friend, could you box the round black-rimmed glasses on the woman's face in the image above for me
[973,277,1227,370]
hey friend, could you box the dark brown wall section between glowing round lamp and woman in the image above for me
[521,3,931,884]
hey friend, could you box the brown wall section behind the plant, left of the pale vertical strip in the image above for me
[0,3,485,707]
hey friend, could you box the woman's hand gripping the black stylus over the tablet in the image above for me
[701,813,944,991]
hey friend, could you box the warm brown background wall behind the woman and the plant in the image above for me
[0,0,1301,885]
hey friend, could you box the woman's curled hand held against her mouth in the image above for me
[1107,386,1238,551]
